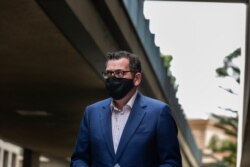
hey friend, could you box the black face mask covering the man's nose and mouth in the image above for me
[105,77,134,100]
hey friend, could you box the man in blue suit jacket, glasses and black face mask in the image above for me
[71,51,182,167]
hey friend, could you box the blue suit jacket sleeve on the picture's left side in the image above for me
[70,109,91,167]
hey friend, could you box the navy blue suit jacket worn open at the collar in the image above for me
[71,93,182,167]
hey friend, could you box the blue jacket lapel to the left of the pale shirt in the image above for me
[100,99,115,158]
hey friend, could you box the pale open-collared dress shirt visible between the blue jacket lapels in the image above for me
[111,91,137,153]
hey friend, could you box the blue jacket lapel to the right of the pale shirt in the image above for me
[116,93,146,161]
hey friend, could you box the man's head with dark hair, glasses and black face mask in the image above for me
[103,51,141,100]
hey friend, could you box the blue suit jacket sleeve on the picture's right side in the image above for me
[157,105,182,167]
